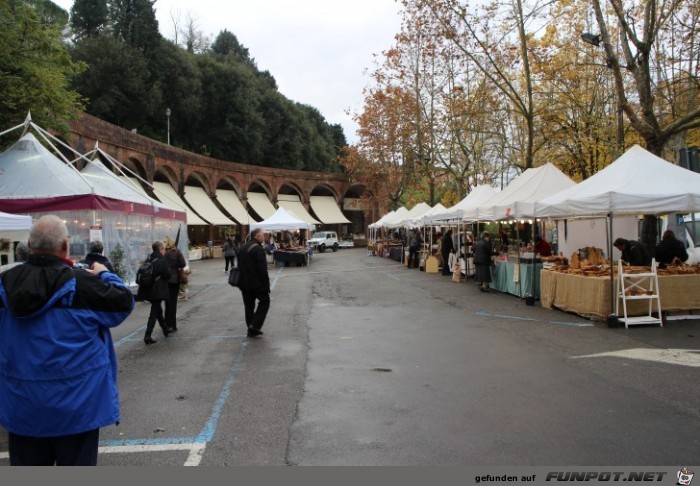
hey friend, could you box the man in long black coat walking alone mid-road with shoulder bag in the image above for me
[238,228,270,337]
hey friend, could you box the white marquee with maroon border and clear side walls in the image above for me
[0,129,186,281]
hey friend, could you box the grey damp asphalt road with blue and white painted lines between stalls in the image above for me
[0,249,700,466]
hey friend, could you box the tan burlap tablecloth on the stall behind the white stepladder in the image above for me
[540,270,700,318]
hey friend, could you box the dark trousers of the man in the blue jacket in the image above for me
[8,429,100,466]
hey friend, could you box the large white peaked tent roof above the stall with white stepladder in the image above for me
[535,145,700,217]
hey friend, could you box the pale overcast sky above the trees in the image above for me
[53,0,400,143]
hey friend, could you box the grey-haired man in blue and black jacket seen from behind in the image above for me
[0,215,134,466]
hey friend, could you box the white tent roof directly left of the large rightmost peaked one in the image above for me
[476,162,576,221]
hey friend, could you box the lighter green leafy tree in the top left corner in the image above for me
[0,1,84,135]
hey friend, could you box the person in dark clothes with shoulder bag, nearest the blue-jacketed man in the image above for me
[136,241,170,345]
